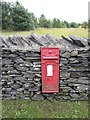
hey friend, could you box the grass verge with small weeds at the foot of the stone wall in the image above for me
[2,100,88,119]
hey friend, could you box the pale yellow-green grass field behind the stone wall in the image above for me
[0,28,88,38]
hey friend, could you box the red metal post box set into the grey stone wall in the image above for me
[41,48,59,93]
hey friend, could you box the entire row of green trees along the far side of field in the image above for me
[1,1,87,31]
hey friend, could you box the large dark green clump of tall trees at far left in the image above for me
[2,2,37,31]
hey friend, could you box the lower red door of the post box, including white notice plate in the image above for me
[42,62,58,92]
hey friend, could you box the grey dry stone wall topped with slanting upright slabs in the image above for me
[0,33,90,101]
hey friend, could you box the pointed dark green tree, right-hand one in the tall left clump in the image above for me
[11,2,35,31]
